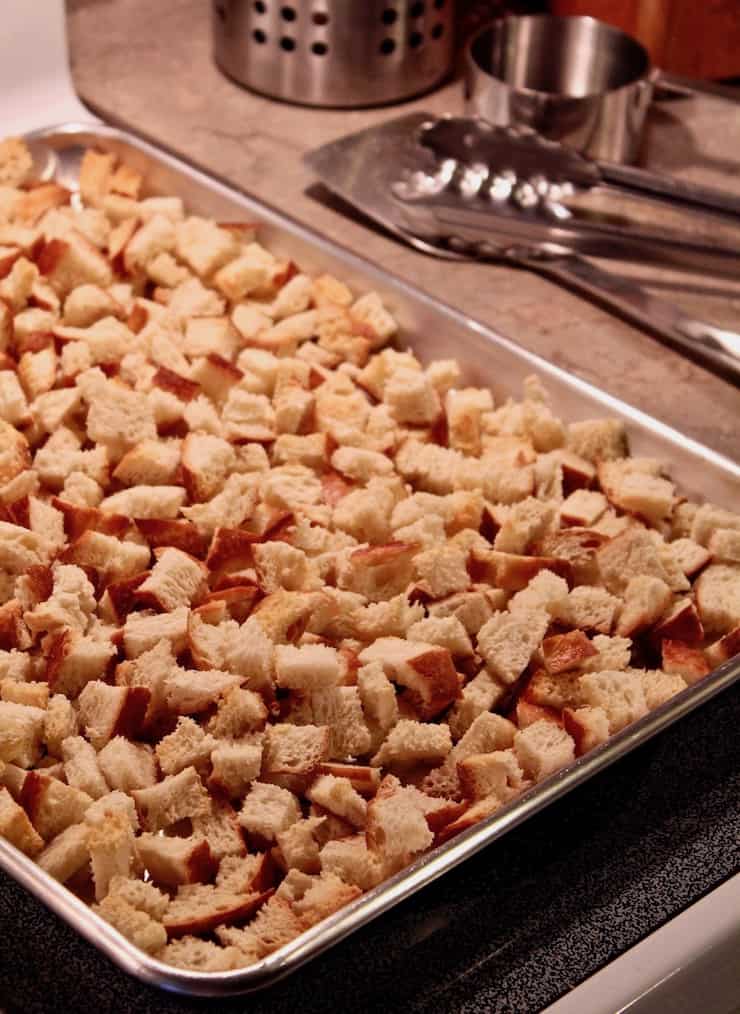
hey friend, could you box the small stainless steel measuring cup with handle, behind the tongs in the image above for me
[465,14,740,162]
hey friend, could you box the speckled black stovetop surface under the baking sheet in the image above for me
[0,684,740,1014]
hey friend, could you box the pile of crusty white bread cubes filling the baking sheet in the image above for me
[0,134,740,971]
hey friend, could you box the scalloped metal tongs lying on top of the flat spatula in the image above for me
[391,117,740,377]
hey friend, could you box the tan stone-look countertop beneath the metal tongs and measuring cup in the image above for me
[68,0,740,460]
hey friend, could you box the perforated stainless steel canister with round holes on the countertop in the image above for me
[213,0,455,107]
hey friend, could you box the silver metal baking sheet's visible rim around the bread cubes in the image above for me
[0,124,740,996]
